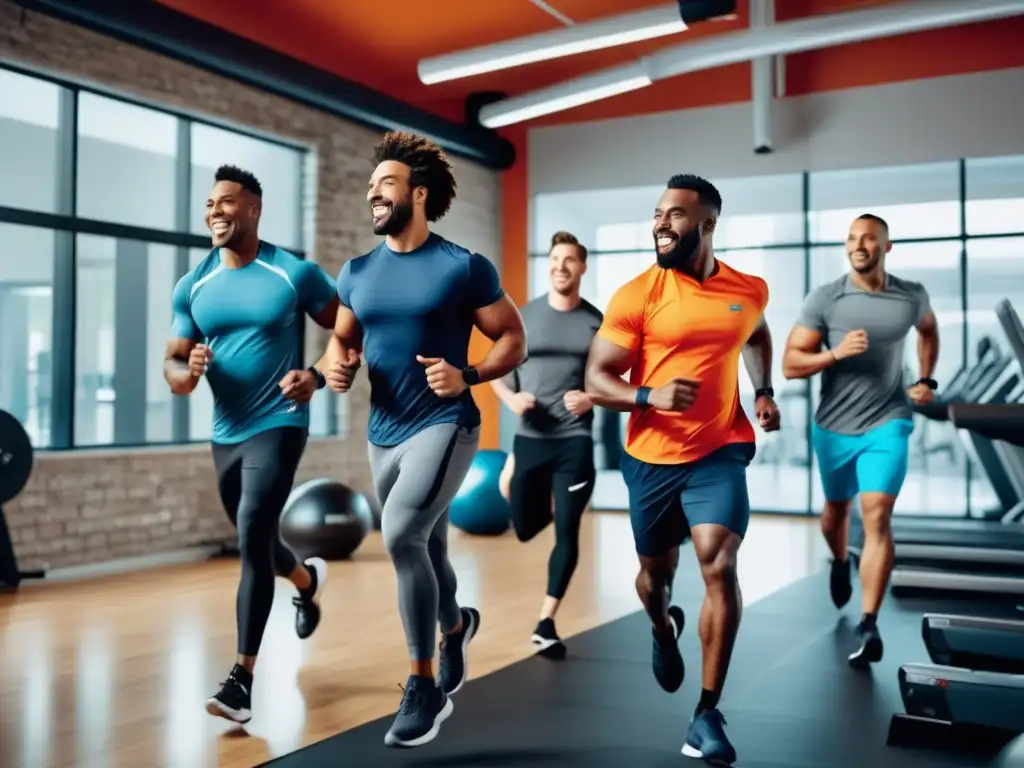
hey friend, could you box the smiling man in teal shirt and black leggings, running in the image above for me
[164,166,338,723]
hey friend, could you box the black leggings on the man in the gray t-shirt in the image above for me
[509,435,595,600]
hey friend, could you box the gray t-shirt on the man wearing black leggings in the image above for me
[505,295,603,437]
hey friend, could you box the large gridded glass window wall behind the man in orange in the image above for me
[530,157,1024,517]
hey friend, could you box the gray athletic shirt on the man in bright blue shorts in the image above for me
[797,274,931,434]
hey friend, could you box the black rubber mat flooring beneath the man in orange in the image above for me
[260,553,1003,768]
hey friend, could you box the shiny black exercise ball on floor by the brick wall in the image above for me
[281,478,374,560]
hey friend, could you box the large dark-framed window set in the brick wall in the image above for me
[0,69,339,449]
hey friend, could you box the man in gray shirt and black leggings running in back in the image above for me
[490,232,602,658]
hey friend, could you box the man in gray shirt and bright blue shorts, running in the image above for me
[782,213,939,669]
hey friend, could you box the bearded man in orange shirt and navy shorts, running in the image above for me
[587,175,779,763]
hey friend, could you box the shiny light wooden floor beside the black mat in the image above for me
[0,513,824,768]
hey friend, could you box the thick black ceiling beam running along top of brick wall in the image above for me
[14,0,515,170]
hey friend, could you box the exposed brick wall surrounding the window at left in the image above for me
[0,0,501,569]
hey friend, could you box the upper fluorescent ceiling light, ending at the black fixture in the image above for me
[417,3,686,85]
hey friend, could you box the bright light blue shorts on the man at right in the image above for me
[814,419,913,502]
